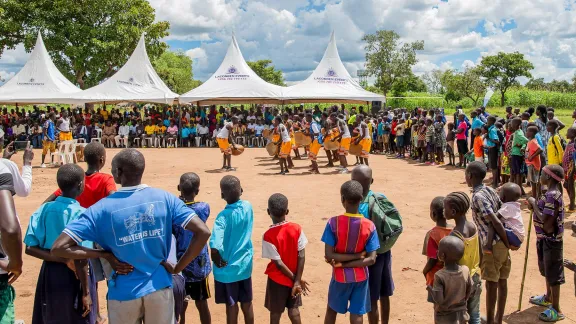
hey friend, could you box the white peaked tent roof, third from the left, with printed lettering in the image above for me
[180,35,282,104]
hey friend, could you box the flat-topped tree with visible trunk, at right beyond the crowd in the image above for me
[480,52,534,106]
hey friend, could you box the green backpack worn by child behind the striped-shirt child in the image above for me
[368,194,403,254]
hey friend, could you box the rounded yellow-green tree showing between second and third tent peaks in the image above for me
[152,51,197,94]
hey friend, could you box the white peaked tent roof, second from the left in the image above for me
[69,35,178,104]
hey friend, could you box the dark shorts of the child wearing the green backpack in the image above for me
[368,251,394,300]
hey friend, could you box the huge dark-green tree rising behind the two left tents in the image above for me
[0,0,170,89]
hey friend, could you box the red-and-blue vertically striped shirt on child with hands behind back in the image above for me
[322,214,380,283]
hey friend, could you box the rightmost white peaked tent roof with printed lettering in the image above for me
[283,32,386,103]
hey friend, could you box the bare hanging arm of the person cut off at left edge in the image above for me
[0,189,22,283]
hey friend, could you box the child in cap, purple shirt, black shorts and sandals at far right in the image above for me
[528,164,565,322]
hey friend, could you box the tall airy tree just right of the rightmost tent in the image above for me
[362,30,424,95]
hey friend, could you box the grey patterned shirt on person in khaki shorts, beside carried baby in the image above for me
[471,184,502,242]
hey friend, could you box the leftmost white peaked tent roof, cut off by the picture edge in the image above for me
[0,32,80,104]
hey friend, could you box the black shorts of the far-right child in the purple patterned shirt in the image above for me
[536,239,566,286]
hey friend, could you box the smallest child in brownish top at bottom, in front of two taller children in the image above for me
[428,235,472,324]
